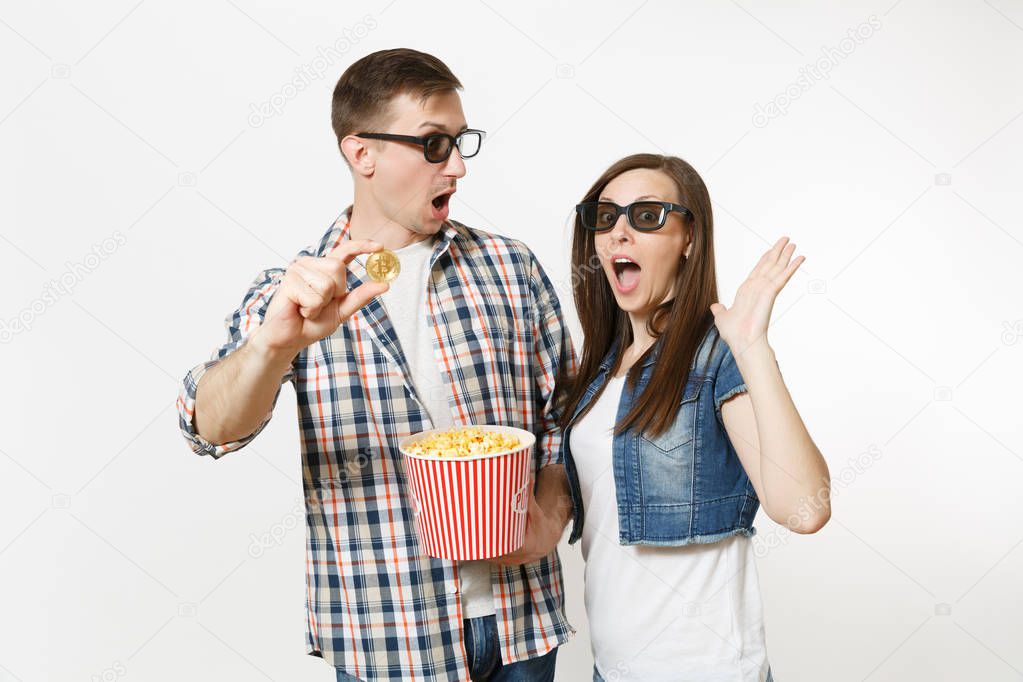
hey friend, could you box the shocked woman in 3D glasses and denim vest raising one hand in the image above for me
[560,154,831,682]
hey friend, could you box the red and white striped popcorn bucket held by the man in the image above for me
[399,426,536,561]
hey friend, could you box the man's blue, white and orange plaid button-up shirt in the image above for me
[177,212,576,680]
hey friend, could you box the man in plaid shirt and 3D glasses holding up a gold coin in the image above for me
[178,49,575,680]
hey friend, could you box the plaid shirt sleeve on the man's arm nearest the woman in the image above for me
[530,248,576,469]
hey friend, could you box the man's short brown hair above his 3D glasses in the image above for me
[330,47,461,162]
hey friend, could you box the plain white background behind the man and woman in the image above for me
[0,0,1023,682]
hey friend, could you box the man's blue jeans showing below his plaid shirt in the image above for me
[338,616,558,682]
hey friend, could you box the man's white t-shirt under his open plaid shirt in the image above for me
[380,237,496,618]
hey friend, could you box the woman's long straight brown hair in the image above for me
[557,153,717,436]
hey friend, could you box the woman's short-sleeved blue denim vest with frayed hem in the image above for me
[563,324,760,545]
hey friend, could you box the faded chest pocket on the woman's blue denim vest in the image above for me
[637,377,704,505]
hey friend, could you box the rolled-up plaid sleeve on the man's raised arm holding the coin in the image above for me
[177,268,295,459]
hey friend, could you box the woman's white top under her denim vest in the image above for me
[570,376,768,682]
